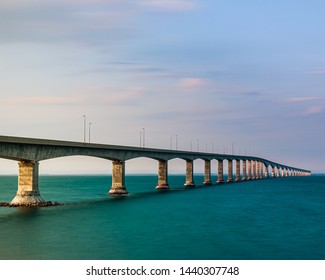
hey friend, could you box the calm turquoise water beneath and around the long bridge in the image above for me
[0,175,325,260]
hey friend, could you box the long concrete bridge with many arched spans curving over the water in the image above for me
[0,136,311,205]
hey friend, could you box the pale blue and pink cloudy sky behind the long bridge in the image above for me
[0,0,325,174]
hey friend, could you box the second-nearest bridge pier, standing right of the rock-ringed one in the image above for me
[108,160,128,196]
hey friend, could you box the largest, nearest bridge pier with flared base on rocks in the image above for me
[10,161,45,206]
